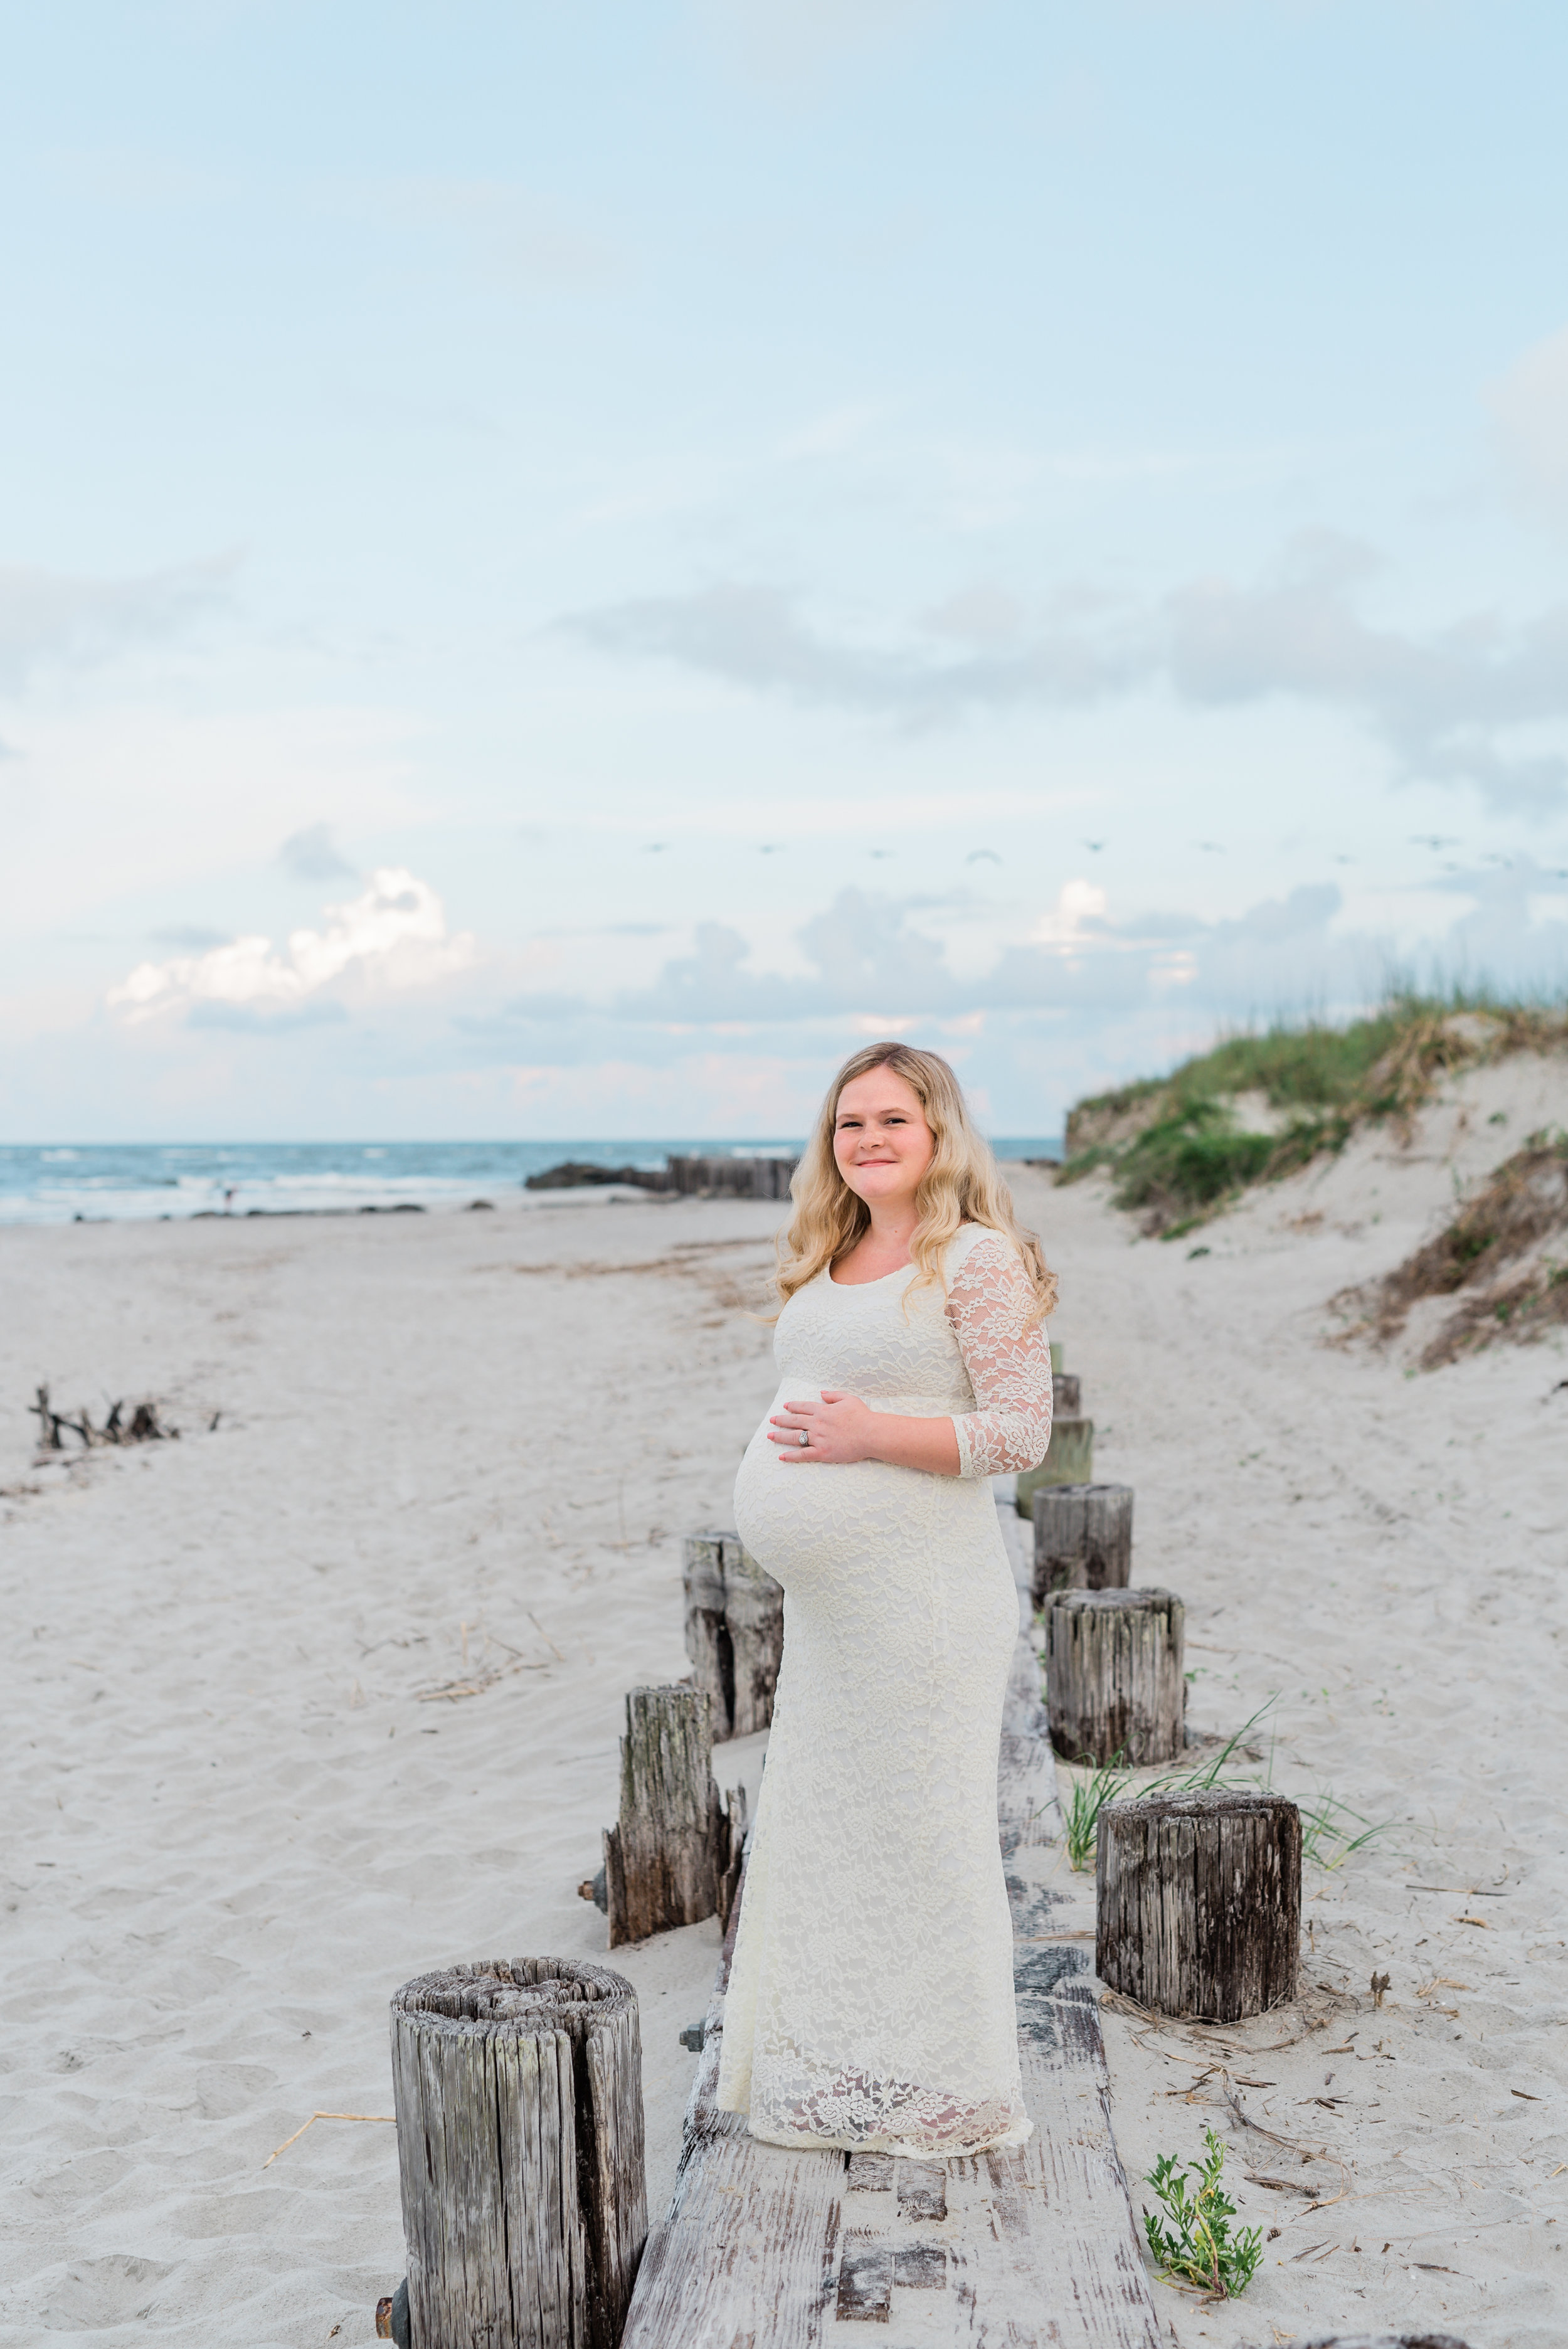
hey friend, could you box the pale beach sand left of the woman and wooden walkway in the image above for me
[0,1202,777,2349]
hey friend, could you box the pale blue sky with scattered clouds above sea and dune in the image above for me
[0,0,1568,1139]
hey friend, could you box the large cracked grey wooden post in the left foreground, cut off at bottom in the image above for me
[392,1957,648,2349]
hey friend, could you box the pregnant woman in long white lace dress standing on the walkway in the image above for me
[718,1043,1056,2156]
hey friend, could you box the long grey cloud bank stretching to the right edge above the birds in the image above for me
[556,538,1568,817]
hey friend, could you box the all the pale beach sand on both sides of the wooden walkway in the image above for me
[0,1062,1568,2349]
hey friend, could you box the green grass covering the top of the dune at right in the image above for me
[1056,987,1568,1240]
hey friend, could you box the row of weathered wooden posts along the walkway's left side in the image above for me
[376,1534,784,2349]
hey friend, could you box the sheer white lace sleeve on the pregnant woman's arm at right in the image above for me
[948,1233,1052,1478]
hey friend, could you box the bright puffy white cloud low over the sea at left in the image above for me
[105,864,474,1019]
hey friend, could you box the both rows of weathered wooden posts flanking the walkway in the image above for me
[376,1374,1463,2349]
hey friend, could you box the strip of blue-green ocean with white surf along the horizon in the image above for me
[0,1137,1061,1224]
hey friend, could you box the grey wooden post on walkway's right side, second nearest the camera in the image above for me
[1044,1590,1188,1764]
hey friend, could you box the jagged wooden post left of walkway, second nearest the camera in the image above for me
[603,1684,746,1949]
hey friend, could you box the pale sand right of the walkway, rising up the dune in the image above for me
[1017,1057,1568,2349]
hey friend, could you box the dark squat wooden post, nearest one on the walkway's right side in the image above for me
[1094,1790,1300,2022]
